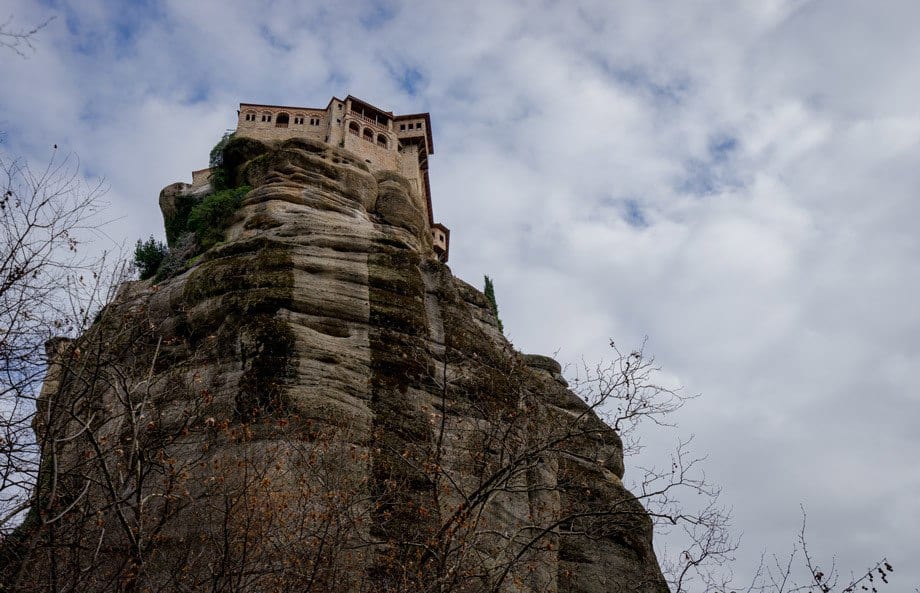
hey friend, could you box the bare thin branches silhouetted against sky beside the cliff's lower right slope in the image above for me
[573,341,739,593]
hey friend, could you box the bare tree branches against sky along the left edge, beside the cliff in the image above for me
[0,150,104,533]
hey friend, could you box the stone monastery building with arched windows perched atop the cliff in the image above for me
[236,95,450,261]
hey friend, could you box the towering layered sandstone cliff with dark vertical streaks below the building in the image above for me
[17,141,667,592]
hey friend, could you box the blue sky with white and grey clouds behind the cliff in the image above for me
[0,0,920,591]
